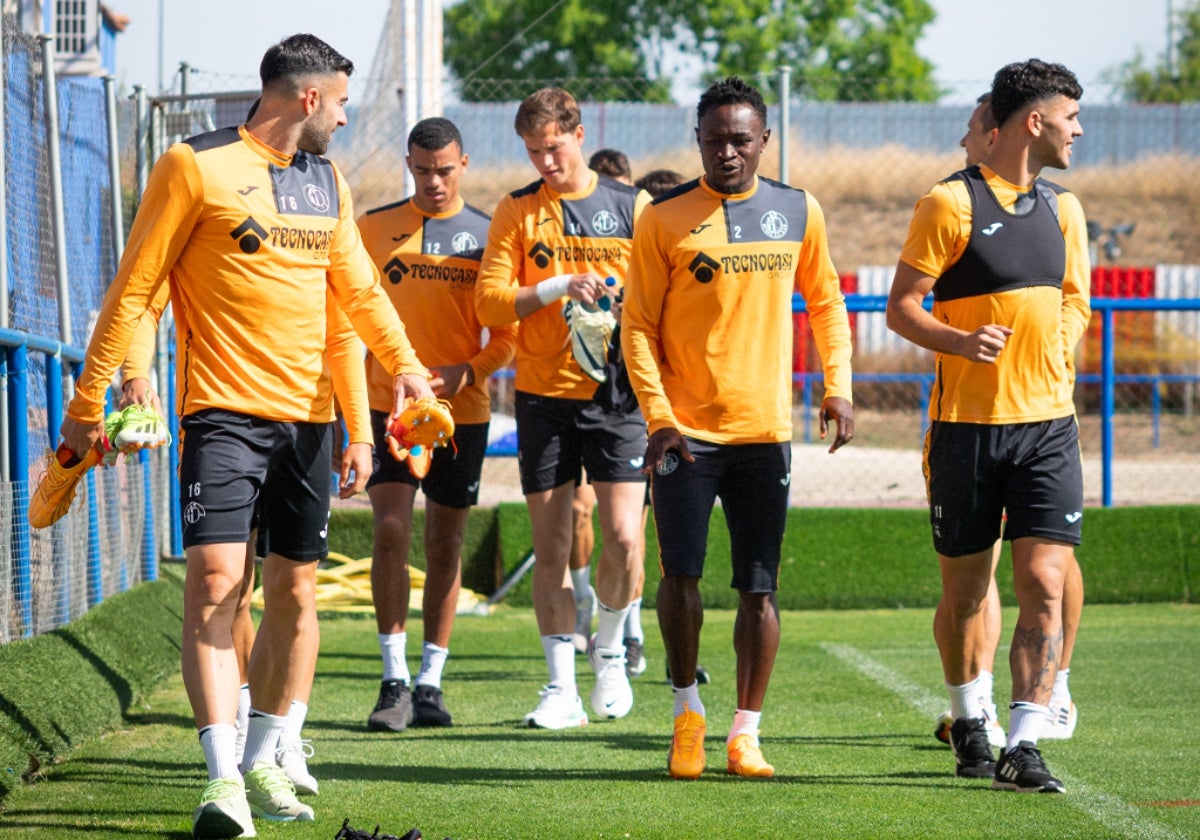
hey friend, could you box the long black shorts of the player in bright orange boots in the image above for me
[650,438,792,593]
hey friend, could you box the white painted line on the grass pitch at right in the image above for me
[821,642,1184,840]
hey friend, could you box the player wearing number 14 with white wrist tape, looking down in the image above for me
[475,88,649,730]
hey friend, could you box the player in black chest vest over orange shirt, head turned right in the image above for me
[887,59,1091,793]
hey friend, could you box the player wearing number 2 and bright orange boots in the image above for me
[622,77,854,779]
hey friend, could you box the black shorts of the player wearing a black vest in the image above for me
[924,416,1084,557]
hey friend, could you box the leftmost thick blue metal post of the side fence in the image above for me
[5,344,34,637]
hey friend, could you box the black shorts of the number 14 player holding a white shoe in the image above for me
[515,391,646,494]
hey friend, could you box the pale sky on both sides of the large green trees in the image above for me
[107,0,1188,101]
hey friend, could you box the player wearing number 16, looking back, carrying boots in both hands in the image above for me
[61,35,432,838]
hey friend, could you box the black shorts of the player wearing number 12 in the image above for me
[367,409,488,508]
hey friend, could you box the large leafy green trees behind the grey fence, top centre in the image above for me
[444,0,940,101]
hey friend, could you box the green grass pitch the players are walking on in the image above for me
[0,605,1200,840]
